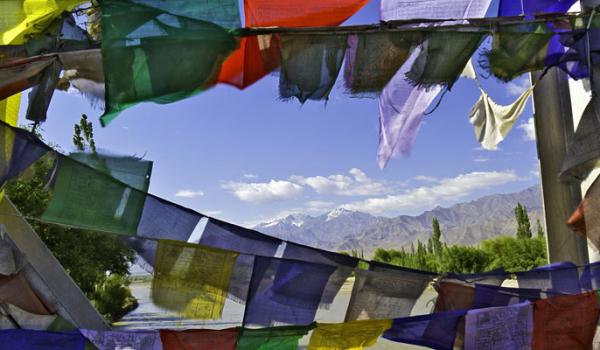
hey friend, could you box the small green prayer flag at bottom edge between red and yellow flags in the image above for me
[236,325,314,350]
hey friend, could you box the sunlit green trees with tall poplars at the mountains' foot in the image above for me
[373,203,548,273]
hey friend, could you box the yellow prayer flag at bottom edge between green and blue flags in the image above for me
[308,320,392,350]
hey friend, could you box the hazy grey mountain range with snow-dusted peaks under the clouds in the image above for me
[254,185,543,256]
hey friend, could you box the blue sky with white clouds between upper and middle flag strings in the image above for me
[20,1,539,225]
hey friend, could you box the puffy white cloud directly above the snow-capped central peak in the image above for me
[290,168,388,196]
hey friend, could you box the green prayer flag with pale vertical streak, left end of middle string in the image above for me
[42,157,146,235]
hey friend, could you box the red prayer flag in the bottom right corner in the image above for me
[531,291,600,350]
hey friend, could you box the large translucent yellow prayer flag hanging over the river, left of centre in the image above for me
[152,240,238,320]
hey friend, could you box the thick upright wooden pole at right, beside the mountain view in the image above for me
[531,68,589,264]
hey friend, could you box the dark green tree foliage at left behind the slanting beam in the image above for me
[5,118,137,322]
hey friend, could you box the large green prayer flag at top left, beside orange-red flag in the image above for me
[101,0,239,125]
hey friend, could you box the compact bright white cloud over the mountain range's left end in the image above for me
[222,180,303,203]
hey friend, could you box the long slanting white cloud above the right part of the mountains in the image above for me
[342,170,519,215]
